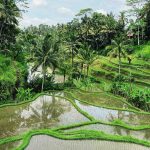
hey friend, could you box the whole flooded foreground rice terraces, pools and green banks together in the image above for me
[0,89,150,150]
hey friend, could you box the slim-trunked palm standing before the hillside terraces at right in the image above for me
[106,38,127,75]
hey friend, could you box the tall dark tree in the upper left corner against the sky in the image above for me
[0,0,21,53]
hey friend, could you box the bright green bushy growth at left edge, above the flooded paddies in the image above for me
[0,55,27,102]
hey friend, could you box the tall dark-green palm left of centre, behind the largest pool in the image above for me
[32,35,58,91]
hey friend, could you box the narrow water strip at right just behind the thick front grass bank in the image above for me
[65,124,150,141]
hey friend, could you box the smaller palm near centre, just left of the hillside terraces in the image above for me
[78,43,97,77]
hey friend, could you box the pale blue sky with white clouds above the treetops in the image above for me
[20,0,126,27]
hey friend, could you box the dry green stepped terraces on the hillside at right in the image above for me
[90,57,150,88]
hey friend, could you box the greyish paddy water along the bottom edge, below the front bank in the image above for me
[26,135,149,150]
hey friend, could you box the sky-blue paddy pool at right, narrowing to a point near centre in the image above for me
[75,100,150,125]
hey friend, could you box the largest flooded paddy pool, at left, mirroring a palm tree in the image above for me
[0,93,88,138]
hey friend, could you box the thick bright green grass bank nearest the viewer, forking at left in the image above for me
[0,129,150,150]
